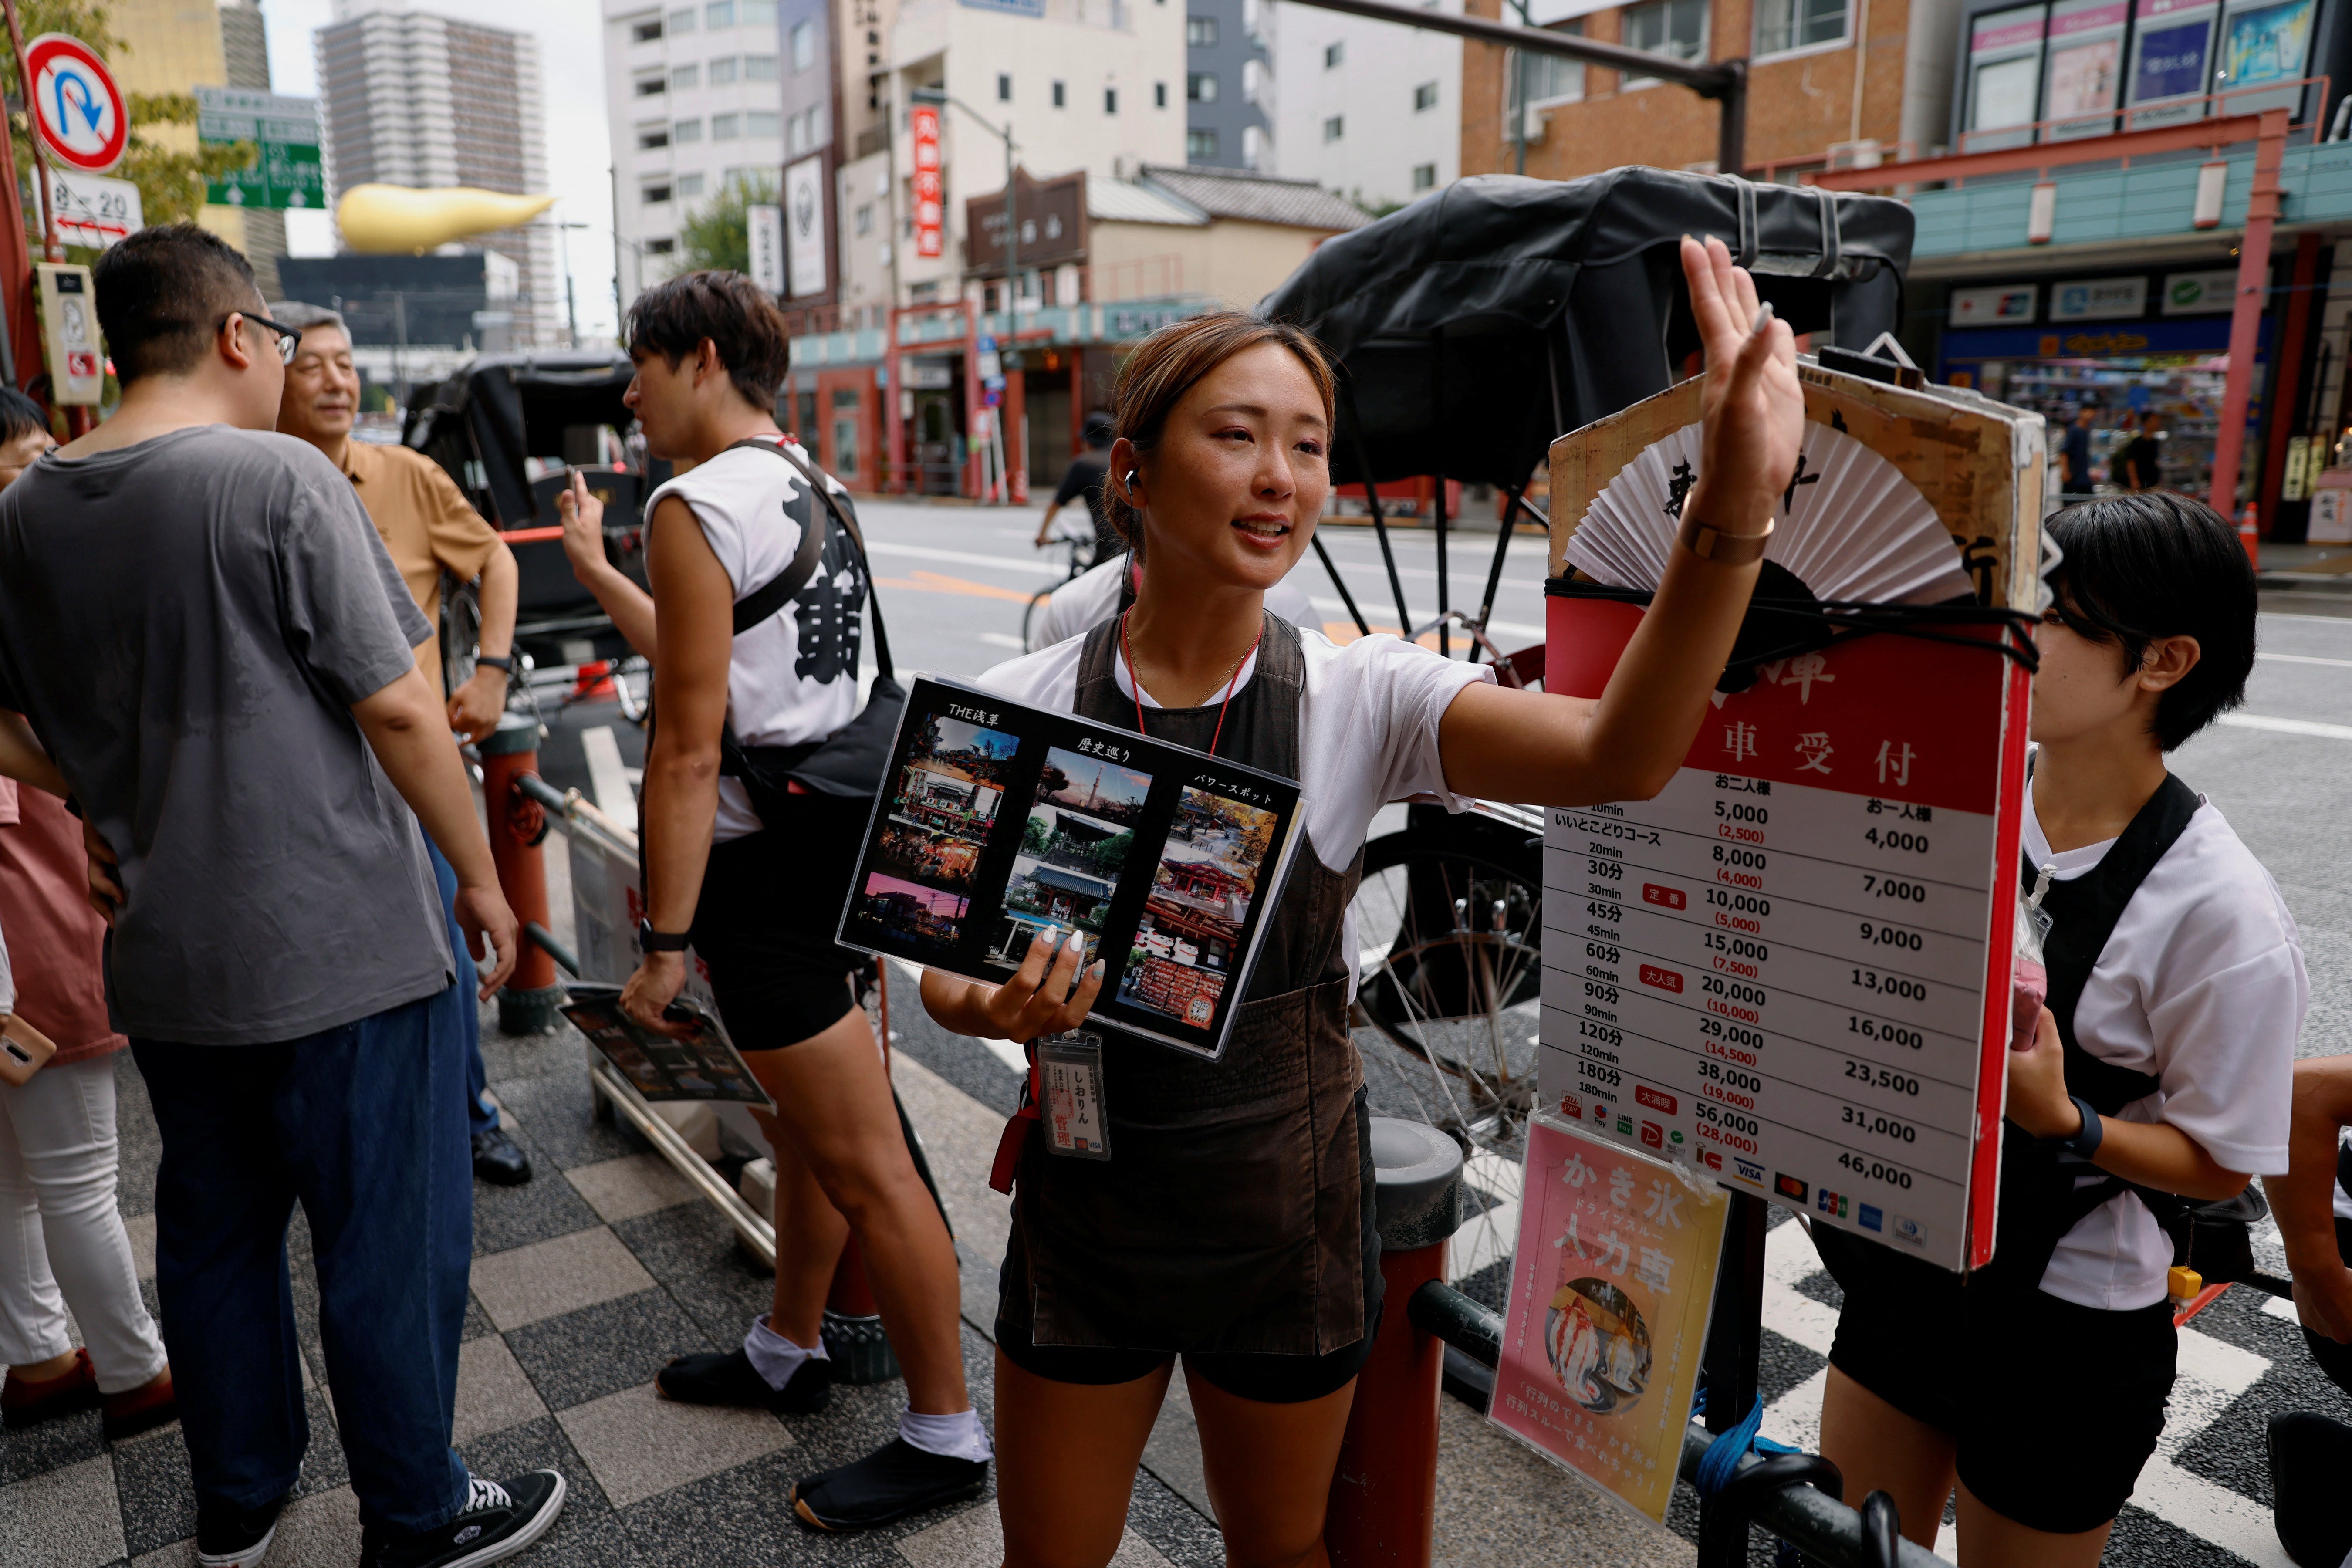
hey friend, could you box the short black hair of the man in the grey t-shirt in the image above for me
[92,223,261,385]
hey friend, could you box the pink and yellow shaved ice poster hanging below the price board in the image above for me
[1487,1114,1731,1523]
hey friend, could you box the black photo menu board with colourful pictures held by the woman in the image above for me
[840,677,1298,1060]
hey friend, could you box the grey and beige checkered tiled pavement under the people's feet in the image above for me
[0,987,1691,1568]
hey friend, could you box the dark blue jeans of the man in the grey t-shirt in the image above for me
[132,985,473,1533]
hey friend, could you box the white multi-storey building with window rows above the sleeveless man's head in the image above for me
[605,0,790,303]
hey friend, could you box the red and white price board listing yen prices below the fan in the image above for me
[1538,597,2030,1270]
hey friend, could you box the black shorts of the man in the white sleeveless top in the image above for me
[694,794,872,1051]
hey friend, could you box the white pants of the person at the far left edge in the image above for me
[0,1055,165,1394]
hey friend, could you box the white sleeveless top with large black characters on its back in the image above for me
[645,430,865,844]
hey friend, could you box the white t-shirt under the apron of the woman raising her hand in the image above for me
[981,630,1494,997]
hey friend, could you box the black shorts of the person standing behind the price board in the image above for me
[1813,1227,2178,1535]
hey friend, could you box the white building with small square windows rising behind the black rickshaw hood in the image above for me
[1256,0,1463,209]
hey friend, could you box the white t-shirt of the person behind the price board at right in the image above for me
[2025,790,2312,1312]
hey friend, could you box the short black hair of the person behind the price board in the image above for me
[2041,491,2256,750]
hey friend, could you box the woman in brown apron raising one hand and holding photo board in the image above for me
[922,240,1804,1568]
